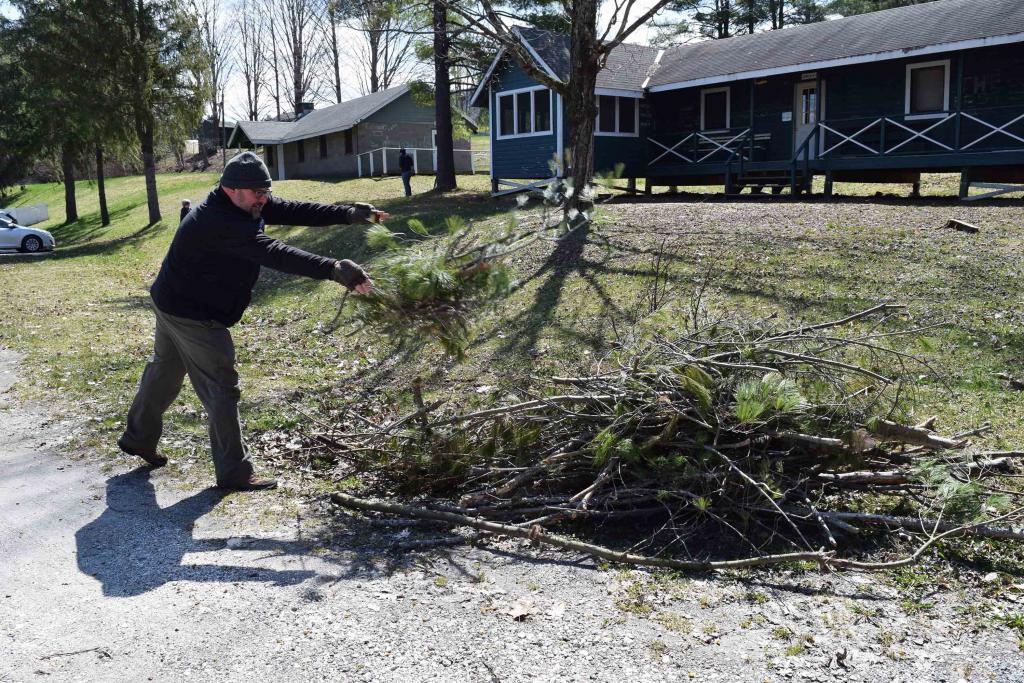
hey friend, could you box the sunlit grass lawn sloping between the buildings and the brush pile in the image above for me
[0,169,1024,491]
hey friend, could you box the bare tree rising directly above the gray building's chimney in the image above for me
[274,0,321,116]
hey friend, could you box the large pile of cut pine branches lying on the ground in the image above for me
[325,304,1024,568]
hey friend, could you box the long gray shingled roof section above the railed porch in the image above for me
[648,0,1024,92]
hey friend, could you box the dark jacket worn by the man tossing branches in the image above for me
[150,187,351,327]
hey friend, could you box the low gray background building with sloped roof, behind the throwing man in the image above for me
[227,84,473,180]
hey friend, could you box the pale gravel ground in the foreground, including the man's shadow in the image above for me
[0,350,1024,683]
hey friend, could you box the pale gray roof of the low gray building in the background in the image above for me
[228,84,409,146]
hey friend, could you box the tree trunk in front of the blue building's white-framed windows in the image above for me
[565,0,600,226]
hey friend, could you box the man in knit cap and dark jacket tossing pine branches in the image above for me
[118,152,388,490]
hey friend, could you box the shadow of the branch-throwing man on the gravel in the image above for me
[75,467,315,597]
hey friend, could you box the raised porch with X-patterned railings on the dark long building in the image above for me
[646,108,1024,194]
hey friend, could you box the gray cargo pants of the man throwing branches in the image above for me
[121,306,253,485]
